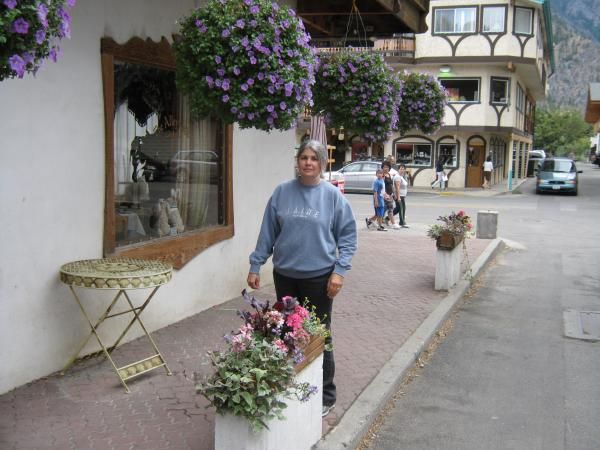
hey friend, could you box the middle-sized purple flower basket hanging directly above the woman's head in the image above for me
[313,50,402,142]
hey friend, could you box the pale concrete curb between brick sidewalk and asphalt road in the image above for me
[313,238,506,450]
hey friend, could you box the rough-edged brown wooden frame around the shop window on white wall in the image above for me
[100,37,234,269]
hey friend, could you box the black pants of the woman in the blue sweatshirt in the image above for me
[273,270,336,406]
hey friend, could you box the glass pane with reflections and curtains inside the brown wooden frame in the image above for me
[114,61,224,247]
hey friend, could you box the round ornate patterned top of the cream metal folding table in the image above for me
[60,258,173,289]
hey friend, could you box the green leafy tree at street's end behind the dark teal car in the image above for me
[533,108,592,157]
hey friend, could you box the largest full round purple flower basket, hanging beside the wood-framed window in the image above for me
[174,0,316,131]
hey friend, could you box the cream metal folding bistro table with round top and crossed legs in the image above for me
[60,258,173,393]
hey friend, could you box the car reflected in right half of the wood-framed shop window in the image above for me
[169,150,219,184]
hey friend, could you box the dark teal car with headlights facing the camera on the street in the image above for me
[535,158,583,195]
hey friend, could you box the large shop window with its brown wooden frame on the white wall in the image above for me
[102,39,233,267]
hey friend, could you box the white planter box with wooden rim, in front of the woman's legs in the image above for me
[215,337,323,450]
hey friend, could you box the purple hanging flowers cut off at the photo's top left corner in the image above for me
[0,0,75,81]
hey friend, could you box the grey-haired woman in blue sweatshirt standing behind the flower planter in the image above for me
[248,140,356,416]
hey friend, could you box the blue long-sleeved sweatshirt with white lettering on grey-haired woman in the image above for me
[250,180,356,279]
